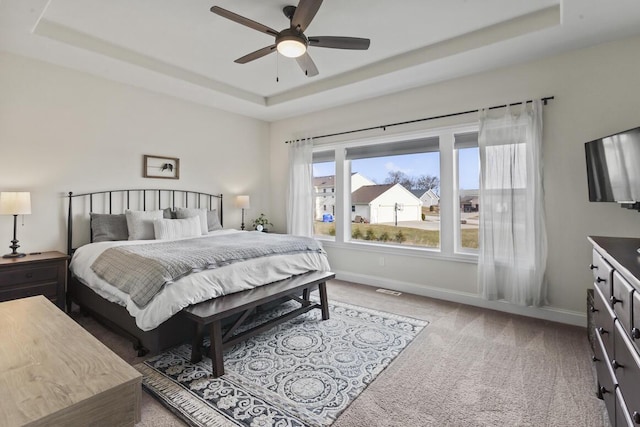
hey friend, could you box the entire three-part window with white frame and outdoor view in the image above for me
[313,125,479,259]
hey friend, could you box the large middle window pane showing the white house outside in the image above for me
[346,137,440,248]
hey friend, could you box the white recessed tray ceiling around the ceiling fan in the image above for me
[0,0,640,121]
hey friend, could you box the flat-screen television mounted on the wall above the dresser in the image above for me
[584,127,640,209]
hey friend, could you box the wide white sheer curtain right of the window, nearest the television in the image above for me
[478,100,547,306]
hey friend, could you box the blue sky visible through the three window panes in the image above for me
[313,148,479,190]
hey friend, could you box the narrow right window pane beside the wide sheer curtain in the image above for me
[454,132,480,251]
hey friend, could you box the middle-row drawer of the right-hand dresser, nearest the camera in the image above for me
[611,321,640,424]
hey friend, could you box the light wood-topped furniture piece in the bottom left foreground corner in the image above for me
[0,296,142,427]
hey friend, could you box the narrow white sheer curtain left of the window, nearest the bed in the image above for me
[287,138,313,237]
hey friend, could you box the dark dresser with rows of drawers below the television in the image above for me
[589,237,640,427]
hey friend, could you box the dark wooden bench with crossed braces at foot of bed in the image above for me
[182,271,336,377]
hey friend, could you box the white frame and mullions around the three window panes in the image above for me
[313,122,479,263]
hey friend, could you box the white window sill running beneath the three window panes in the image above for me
[316,241,478,264]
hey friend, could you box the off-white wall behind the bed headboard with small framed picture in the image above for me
[0,53,270,254]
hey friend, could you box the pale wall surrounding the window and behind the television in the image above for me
[271,37,640,323]
